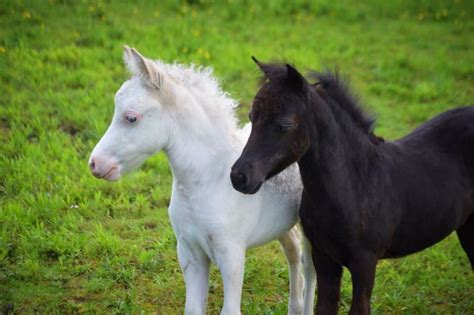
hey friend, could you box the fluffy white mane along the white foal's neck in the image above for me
[154,60,238,133]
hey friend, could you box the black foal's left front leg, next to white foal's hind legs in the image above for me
[313,248,342,315]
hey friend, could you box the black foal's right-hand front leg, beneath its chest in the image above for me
[347,253,377,315]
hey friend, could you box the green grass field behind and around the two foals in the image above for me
[0,0,474,314]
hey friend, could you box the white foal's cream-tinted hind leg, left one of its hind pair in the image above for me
[278,226,304,315]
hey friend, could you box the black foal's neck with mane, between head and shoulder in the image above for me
[298,93,376,194]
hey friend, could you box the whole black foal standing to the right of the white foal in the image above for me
[231,63,474,314]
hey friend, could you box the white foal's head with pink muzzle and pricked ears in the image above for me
[89,46,183,180]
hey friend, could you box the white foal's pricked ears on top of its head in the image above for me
[123,46,165,89]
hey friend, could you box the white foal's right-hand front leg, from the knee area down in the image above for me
[215,245,245,315]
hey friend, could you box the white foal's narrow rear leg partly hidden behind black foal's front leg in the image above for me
[303,237,316,315]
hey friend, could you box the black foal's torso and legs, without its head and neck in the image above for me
[298,107,474,314]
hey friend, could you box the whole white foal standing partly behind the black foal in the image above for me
[89,47,316,314]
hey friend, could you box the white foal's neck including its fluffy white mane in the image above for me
[158,62,238,185]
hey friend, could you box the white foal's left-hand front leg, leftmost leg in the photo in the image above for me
[178,241,210,315]
